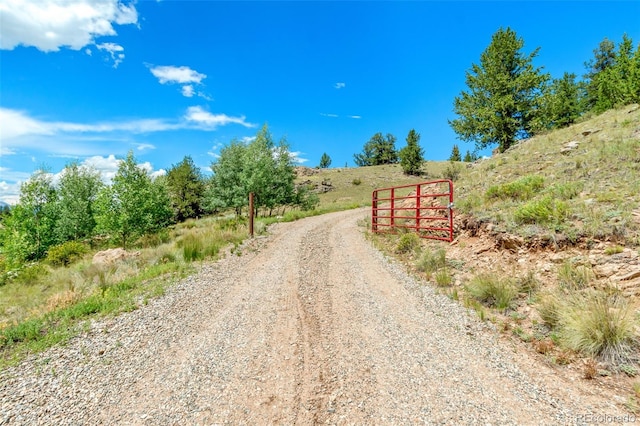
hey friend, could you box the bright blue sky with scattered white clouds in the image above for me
[0,0,640,203]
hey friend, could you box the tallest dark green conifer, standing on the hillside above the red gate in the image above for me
[449,28,548,152]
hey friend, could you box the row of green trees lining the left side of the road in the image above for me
[0,125,318,270]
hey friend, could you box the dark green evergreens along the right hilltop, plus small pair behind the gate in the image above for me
[354,27,640,168]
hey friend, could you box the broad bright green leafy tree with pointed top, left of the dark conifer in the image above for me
[96,151,172,249]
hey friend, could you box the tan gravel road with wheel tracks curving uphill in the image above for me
[0,209,624,425]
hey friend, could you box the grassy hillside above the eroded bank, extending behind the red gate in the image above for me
[308,106,640,246]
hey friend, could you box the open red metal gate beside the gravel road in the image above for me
[371,179,453,242]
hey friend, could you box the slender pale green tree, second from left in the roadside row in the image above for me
[56,161,103,242]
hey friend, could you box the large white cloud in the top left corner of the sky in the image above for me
[0,0,138,65]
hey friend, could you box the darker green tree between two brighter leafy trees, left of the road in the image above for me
[166,156,205,222]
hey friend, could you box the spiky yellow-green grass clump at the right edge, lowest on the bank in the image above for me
[560,292,638,365]
